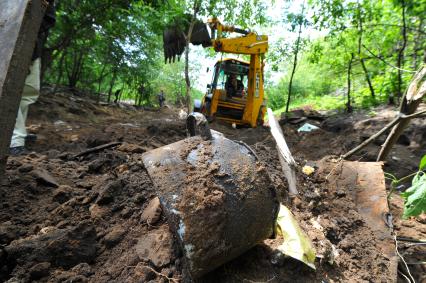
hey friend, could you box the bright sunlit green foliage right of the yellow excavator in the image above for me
[268,0,426,112]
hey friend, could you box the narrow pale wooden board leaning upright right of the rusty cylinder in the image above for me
[268,108,298,194]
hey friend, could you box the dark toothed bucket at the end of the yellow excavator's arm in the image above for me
[163,20,211,63]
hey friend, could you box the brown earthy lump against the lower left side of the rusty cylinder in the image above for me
[135,225,173,267]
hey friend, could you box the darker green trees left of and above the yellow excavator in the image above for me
[43,0,266,105]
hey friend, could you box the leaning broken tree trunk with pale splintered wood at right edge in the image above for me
[377,66,426,161]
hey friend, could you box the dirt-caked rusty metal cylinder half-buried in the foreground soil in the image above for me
[143,117,279,279]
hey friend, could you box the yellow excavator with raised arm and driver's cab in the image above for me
[163,18,268,127]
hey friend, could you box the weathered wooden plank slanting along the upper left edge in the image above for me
[0,0,45,176]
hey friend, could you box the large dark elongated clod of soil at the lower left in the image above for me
[5,221,96,268]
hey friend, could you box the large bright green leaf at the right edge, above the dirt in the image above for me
[401,173,426,219]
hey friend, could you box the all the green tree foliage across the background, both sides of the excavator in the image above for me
[39,0,426,110]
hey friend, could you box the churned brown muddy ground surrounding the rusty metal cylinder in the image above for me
[0,88,426,282]
